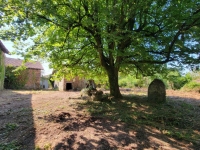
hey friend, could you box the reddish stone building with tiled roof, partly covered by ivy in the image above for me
[5,58,43,89]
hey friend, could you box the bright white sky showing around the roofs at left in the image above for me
[2,40,52,75]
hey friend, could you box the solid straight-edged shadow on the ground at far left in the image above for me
[0,90,35,150]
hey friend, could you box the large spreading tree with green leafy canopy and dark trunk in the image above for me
[0,0,200,98]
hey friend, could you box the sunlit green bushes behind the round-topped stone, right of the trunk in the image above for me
[119,69,200,92]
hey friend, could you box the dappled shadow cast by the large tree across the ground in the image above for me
[46,92,200,150]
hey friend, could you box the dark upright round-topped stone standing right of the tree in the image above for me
[148,79,166,103]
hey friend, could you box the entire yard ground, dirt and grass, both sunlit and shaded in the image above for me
[0,91,200,150]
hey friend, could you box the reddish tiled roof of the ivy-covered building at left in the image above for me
[5,57,44,70]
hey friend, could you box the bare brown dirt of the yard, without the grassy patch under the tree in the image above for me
[0,89,200,150]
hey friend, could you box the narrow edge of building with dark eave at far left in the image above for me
[0,40,9,90]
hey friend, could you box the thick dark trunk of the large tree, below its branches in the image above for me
[107,67,122,98]
